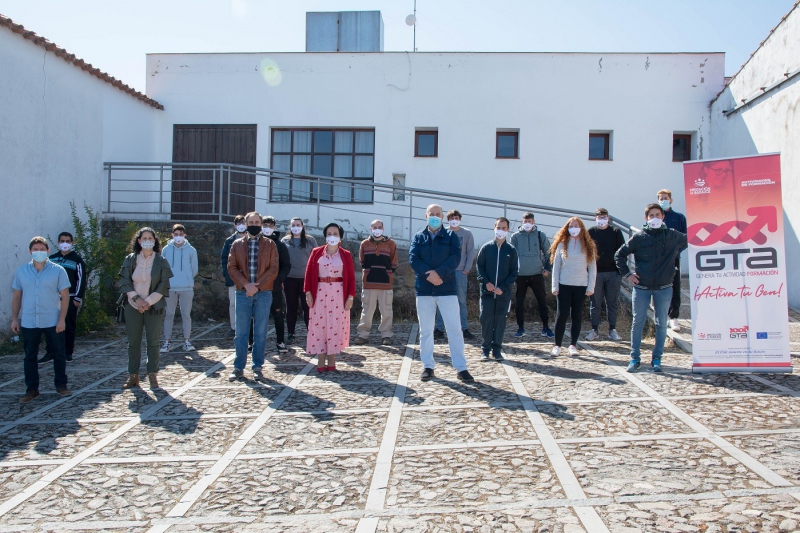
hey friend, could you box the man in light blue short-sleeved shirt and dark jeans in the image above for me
[11,237,72,403]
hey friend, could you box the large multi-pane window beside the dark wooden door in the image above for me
[270,129,375,202]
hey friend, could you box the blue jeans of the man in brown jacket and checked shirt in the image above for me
[233,289,272,370]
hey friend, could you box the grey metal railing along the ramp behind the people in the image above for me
[103,162,639,242]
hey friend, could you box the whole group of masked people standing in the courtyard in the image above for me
[11,189,687,403]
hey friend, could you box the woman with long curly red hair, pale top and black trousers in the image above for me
[550,217,597,357]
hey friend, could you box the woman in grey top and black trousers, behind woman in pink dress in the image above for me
[281,217,317,344]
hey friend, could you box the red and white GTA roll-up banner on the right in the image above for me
[683,154,792,372]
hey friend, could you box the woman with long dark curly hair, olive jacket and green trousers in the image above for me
[119,227,172,389]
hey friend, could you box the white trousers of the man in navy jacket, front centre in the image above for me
[417,296,467,372]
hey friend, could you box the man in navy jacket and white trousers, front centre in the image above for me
[408,204,475,383]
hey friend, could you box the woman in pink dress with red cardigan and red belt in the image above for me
[303,223,356,373]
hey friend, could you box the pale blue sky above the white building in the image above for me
[0,0,795,91]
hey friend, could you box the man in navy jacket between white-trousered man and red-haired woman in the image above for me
[477,217,519,361]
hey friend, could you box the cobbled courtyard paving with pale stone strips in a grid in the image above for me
[0,318,800,533]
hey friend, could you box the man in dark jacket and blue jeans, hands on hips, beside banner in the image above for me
[614,204,686,372]
